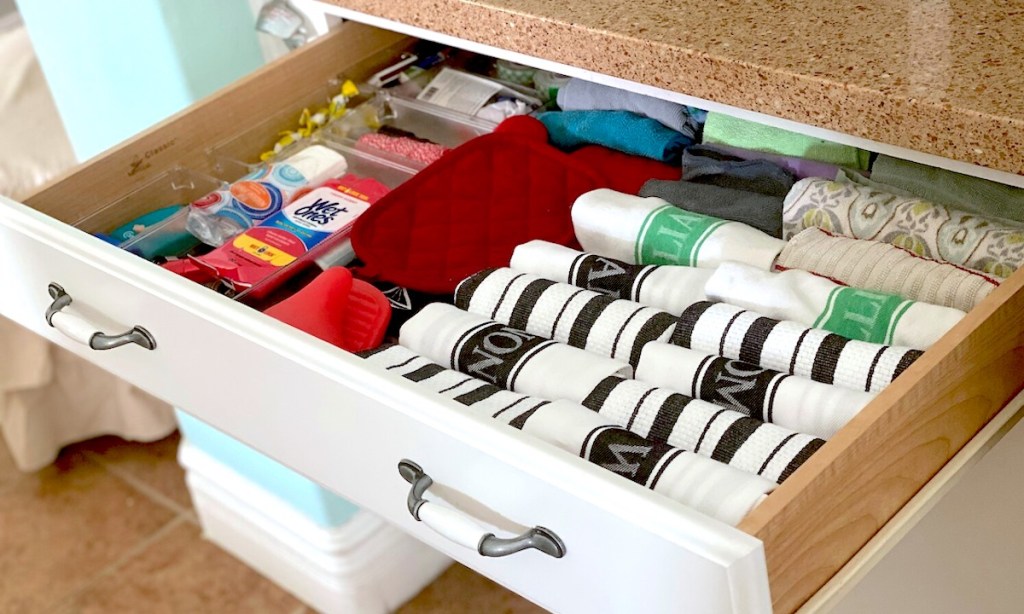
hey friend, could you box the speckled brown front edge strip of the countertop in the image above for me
[327,0,1024,175]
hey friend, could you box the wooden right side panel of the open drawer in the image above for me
[740,270,1024,612]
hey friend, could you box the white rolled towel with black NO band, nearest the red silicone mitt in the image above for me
[398,303,633,403]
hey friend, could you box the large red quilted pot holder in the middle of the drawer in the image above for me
[351,118,605,294]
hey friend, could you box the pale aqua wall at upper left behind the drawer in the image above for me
[17,0,263,161]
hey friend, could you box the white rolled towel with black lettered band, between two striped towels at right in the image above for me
[636,343,874,439]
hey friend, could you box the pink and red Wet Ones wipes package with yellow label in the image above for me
[193,175,388,296]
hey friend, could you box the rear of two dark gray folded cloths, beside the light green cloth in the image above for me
[681,145,796,198]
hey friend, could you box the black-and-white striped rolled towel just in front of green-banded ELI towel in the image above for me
[671,302,922,392]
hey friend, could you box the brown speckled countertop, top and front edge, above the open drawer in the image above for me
[330,0,1024,175]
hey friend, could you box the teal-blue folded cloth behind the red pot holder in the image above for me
[537,111,693,163]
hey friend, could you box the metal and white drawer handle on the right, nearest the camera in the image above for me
[398,459,565,559]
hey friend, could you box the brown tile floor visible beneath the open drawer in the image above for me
[0,435,543,614]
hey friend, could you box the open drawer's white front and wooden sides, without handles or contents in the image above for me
[6,16,1024,612]
